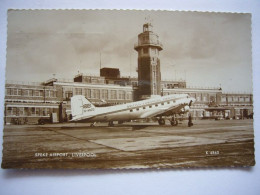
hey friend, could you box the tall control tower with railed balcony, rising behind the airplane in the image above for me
[134,23,163,99]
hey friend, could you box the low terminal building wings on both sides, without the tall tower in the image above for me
[5,71,253,124]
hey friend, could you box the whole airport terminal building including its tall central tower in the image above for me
[4,23,253,124]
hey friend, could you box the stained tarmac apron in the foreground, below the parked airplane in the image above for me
[2,119,255,169]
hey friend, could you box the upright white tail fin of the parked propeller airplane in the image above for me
[71,95,95,118]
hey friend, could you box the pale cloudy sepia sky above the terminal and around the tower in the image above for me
[6,10,252,93]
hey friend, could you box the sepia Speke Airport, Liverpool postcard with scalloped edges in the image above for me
[1,10,255,169]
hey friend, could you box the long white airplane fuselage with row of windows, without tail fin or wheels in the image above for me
[72,94,194,122]
